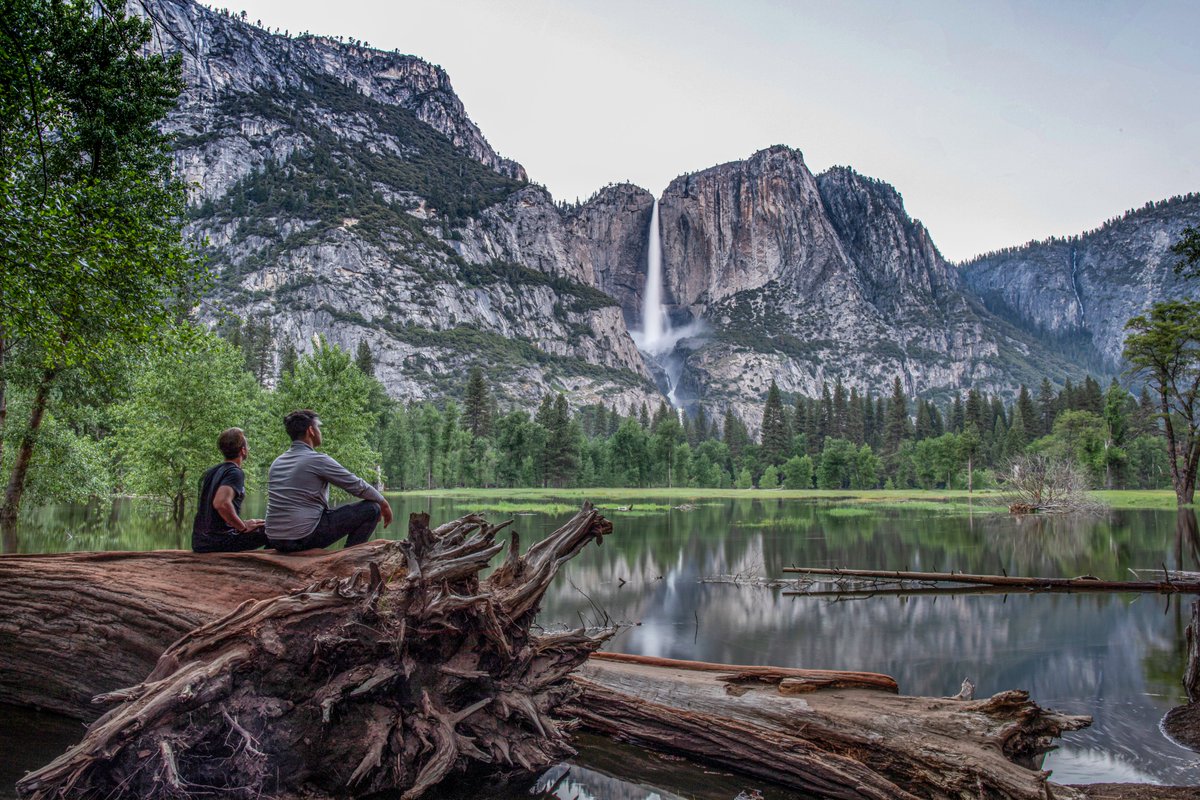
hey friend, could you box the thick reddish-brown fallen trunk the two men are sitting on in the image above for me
[0,541,403,720]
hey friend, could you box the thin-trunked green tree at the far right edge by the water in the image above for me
[1124,300,1200,505]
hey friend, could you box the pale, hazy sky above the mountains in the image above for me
[218,0,1200,260]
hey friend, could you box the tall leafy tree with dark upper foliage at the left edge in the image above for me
[0,0,196,524]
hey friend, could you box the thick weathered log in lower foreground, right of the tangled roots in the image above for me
[565,656,1091,800]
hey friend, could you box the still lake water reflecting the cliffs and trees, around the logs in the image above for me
[0,495,1200,800]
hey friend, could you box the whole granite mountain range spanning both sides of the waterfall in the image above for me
[142,0,1200,429]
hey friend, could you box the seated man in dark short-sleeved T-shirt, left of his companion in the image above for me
[192,428,266,553]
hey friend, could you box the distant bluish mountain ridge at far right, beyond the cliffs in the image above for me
[962,193,1200,369]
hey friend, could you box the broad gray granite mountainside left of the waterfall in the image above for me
[146,0,659,411]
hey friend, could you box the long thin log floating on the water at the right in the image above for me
[784,566,1200,594]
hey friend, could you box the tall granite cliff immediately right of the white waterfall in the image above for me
[661,148,1074,422]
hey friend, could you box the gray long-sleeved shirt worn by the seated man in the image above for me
[266,441,384,540]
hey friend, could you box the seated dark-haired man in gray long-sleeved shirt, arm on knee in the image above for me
[266,409,391,553]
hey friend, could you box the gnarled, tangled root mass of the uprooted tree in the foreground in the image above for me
[18,506,612,800]
